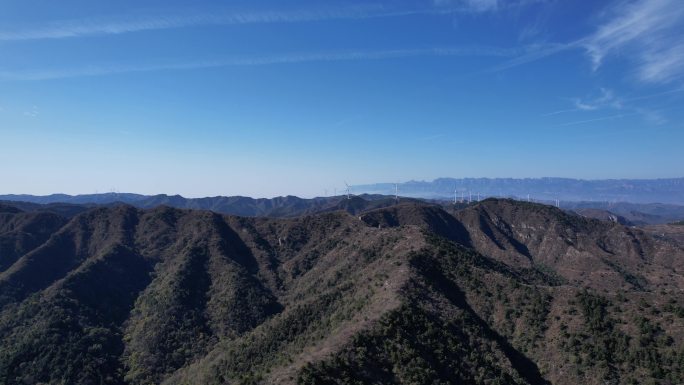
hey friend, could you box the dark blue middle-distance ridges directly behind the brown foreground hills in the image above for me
[0,188,684,225]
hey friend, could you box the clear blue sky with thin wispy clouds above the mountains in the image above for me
[0,0,684,197]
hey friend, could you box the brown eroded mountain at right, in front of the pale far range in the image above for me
[456,199,684,289]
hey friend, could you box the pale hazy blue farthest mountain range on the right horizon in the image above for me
[353,178,684,204]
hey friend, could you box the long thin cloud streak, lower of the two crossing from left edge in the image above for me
[0,46,517,81]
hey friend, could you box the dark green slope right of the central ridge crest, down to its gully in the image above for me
[298,240,548,384]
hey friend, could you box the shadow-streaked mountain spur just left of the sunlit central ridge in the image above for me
[123,207,281,384]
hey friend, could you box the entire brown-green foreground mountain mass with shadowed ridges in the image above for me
[0,197,684,385]
